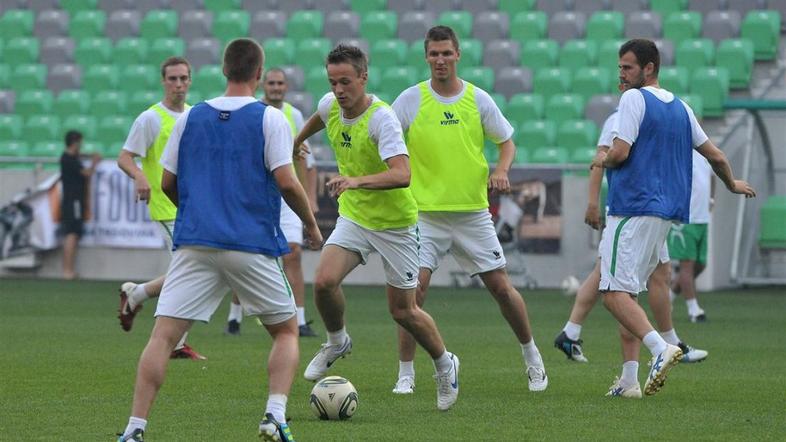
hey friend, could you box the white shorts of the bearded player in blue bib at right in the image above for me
[599,216,671,295]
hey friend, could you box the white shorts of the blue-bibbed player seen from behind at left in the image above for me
[155,247,296,325]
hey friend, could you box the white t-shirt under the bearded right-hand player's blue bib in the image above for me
[612,86,708,147]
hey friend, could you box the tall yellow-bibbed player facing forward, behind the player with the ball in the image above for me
[393,26,548,394]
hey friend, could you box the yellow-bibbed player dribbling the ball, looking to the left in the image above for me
[294,44,459,410]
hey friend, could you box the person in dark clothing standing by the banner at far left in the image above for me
[60,130,101,279]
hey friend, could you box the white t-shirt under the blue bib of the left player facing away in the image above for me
[161,97,292,175]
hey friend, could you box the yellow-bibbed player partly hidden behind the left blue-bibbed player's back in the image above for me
[117,57,206,360]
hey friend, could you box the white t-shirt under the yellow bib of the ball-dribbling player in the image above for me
[317,92,409,161]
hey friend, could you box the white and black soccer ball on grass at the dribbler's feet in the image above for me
[310,376,358,421]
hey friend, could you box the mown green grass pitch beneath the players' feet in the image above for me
[0,280,786,441]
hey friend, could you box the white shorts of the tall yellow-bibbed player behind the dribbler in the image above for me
[418,210,507,276]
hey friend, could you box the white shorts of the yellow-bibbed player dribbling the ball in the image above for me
[325,216,418,289]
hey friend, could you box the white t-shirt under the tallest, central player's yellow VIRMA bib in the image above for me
[393,80,513,144]
